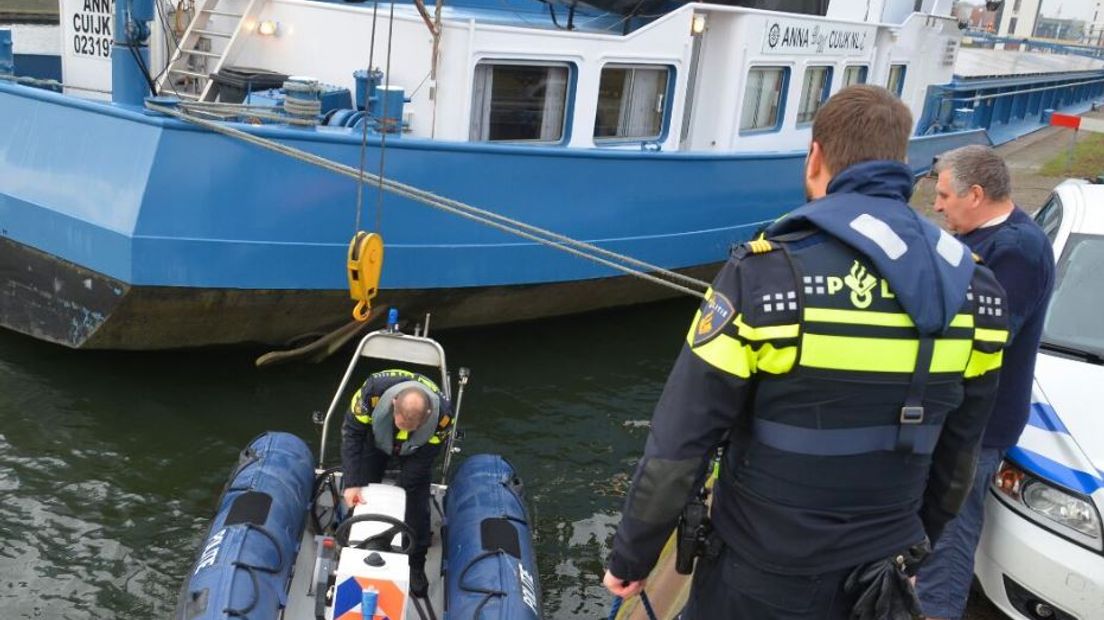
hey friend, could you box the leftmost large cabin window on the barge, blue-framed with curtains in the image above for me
[469,63,569,142]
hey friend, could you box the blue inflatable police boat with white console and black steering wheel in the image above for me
[174,319,541,620]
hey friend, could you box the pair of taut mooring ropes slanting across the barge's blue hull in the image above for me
[146,101,710,299]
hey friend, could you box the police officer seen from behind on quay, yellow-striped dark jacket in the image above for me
[605,86,1007,620]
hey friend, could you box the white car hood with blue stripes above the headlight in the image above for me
[1010,353,1104,495]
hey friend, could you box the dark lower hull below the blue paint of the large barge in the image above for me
[0,233,720,350]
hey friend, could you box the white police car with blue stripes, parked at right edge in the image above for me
[975,181,1104,620]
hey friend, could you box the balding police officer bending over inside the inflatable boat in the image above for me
[341,370,453,597]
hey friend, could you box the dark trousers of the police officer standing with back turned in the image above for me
[682,547,854,620]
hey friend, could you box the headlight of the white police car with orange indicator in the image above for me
[992,460,1104,550]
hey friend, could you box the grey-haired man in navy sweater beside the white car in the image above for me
[916,146,1054,620]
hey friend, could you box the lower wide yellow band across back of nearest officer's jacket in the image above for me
[800,333,973,373]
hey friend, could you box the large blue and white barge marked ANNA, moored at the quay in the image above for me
[0,0,1104,349]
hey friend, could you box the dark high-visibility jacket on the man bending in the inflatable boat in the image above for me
[341,368,453,487]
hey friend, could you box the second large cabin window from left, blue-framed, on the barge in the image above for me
[594,65,671,139]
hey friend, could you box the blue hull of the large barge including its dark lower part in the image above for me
[0,83,986,350]
